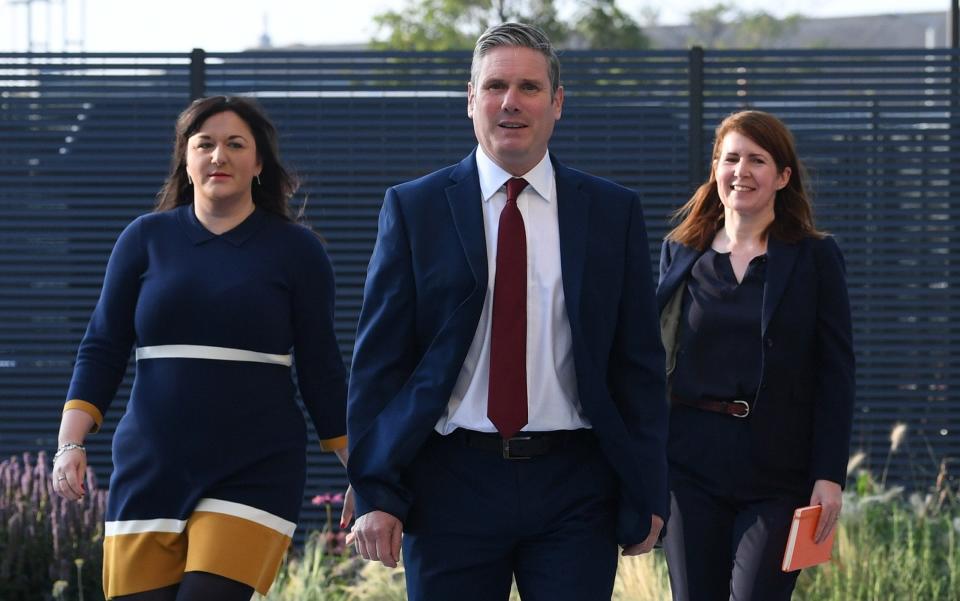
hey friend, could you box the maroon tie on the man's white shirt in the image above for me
[487,177,527,439]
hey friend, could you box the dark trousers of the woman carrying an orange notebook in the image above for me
[663,408,810,601]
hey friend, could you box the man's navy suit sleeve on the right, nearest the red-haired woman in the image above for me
[608,195,669,544]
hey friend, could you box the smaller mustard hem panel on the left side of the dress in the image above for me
[103,532,187,599]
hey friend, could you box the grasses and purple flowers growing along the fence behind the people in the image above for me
[9,414,960,601]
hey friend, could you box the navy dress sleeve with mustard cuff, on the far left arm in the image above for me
[64,219,147,432]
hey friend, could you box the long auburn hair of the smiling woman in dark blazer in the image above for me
[667,111,824,250]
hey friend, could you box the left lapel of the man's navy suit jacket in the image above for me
[446,151,489,293]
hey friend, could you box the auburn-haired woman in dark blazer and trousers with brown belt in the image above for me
[657,111,854,601]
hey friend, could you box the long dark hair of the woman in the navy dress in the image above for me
[154,96,300,221]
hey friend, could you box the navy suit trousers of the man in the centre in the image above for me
[403,428,617,601]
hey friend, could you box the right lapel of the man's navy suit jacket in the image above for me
[550,156,591,329]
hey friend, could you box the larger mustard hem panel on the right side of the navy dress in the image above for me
[184,511,291,595]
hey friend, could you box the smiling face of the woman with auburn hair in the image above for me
[714,131,790,220]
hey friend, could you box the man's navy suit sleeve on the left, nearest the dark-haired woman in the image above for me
[347,188,418,521]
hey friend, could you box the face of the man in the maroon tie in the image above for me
[467,46,563,176]
